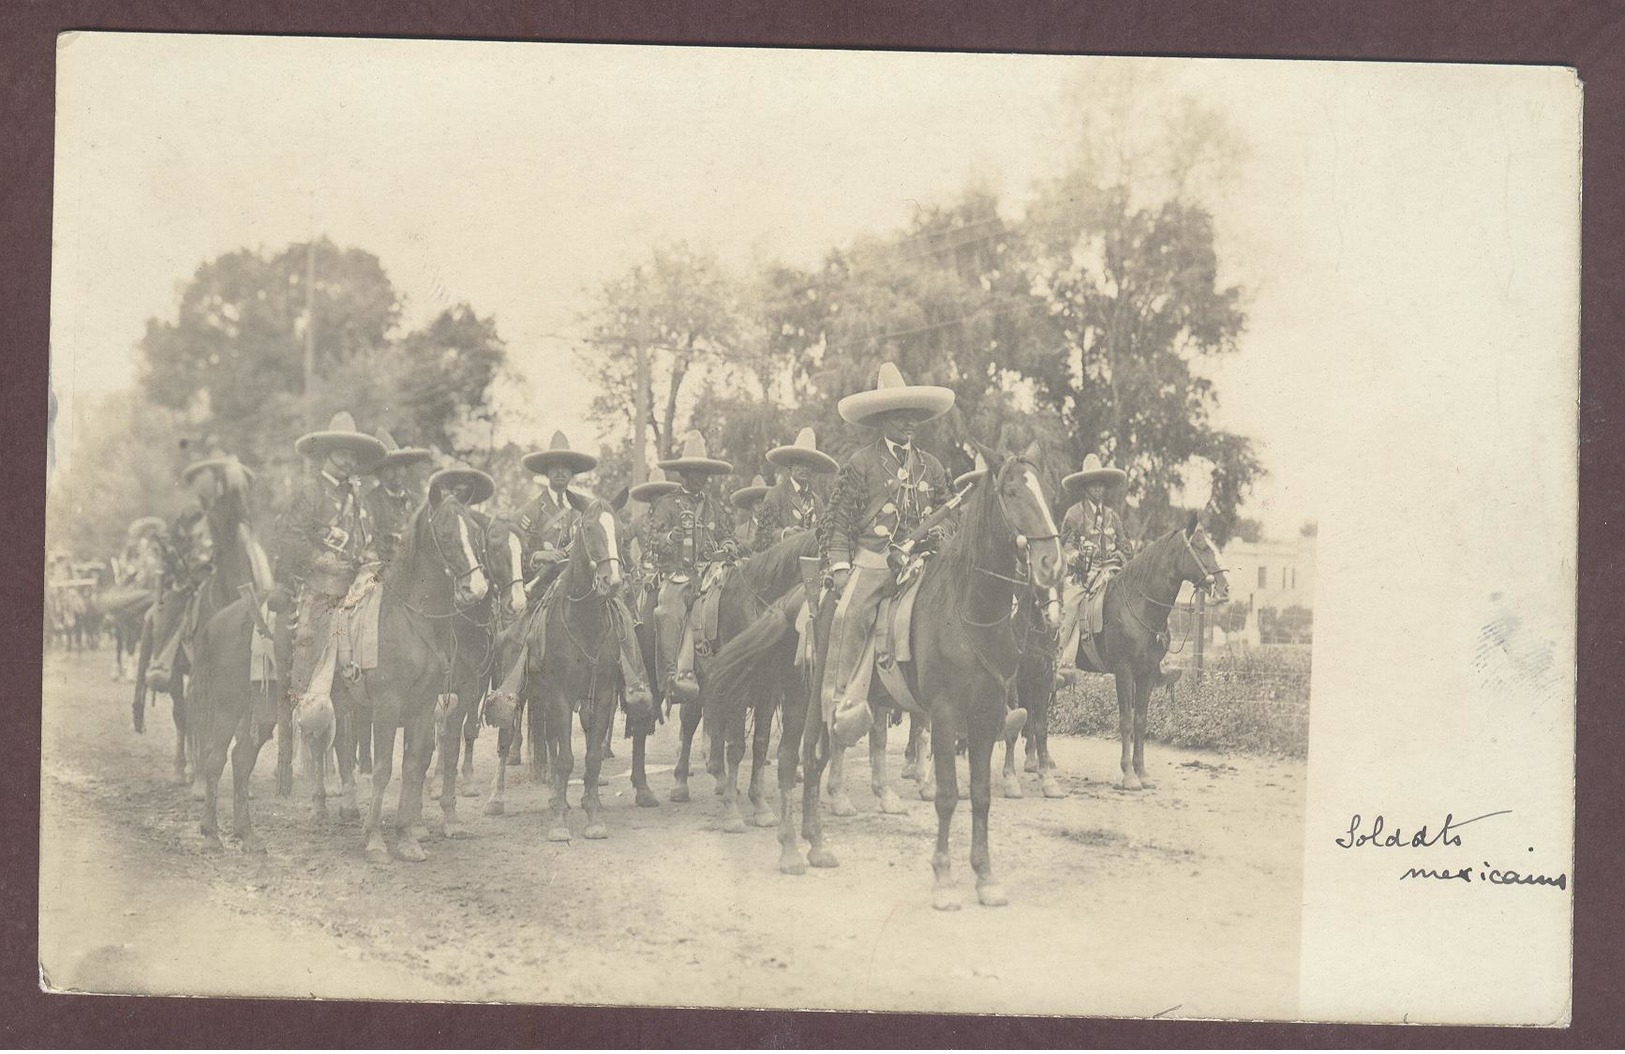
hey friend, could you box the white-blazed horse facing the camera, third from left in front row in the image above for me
[522,490,633,841]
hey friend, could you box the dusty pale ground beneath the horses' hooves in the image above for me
[41,653,1305,1017]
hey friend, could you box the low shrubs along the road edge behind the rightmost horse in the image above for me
[1050,648,1310,757]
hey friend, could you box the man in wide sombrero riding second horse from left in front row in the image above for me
[275,411,385,715]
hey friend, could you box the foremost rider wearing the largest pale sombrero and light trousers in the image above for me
[821,362,954,745]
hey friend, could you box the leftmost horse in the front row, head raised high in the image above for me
[130,461,271,789]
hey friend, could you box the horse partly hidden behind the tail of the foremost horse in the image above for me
[698,531,817,835]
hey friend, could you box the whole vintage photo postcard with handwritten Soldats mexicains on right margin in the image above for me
[39,32,1581,1025]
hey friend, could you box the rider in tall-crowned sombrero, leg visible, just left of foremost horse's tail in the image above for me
[644,430,739,702]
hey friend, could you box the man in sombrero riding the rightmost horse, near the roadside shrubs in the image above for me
[1056,453,1129,682]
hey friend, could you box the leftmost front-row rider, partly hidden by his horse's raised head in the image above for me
[144,448,236,692]
